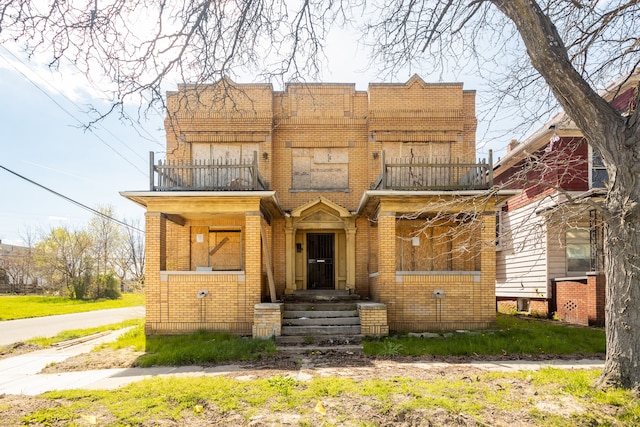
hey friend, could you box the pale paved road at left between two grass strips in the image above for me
[0,306,145,345]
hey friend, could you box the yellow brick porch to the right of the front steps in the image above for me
[358,190,496,331]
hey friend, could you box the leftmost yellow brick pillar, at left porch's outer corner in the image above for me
[144,212,167,332]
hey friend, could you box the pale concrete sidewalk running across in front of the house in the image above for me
[0,329,604,396]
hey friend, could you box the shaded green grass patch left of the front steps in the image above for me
[136,331,276,366]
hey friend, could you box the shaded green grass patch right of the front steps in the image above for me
[363,313,606,356]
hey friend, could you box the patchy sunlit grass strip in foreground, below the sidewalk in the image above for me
[20,369,640,426]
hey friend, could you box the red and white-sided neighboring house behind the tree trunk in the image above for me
[493,73,640,324]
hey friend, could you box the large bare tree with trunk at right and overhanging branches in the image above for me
[0,0,640,387]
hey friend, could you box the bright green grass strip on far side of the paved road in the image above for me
[0,293,144,320]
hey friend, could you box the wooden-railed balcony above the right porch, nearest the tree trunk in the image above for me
[373,150,493,191]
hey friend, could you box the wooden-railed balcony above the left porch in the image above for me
[149,152,268,191]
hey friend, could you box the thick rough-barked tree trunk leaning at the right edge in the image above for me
[491,0,640,390]
